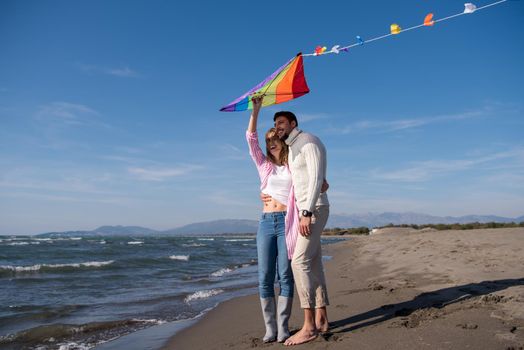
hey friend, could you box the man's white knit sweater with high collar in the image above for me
[286,128,329,212]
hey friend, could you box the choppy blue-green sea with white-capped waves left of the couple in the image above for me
[0,235,344,350]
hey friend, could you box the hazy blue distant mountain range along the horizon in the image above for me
[37,213,524,237]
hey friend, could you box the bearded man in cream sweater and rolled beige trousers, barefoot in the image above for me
[273,111,329,345]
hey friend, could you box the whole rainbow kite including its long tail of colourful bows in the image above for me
[220,0,508,112]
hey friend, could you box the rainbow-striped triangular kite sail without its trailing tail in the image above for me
[220,53,309,112]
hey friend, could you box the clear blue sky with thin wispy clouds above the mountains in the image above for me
[0,0,524,234]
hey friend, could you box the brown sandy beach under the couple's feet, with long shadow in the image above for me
[165,228,524,350]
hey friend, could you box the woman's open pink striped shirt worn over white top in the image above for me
[246,131,299,260]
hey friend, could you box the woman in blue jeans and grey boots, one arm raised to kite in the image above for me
[246,97,298,343]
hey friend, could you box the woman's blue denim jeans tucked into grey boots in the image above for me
[257,211,294,298]
